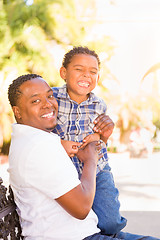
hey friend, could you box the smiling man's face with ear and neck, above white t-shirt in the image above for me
[13,78,58,132]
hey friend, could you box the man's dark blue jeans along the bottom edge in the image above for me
[83,232,159,240]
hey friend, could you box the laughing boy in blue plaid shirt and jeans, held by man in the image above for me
[53,47,126,234]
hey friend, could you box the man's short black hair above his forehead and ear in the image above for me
[8,74,42,107]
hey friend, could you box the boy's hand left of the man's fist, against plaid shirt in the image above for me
[61,139,81,157]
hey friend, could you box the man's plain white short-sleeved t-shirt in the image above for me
[8,124,100,240]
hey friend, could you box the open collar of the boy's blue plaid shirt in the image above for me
[57,84,100,105]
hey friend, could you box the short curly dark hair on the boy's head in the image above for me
[62,46,101,68]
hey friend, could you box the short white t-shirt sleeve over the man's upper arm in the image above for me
[25,134,80,199]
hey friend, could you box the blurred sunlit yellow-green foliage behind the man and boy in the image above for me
[0,0,124,153]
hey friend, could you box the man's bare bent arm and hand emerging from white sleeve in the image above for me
[56,142,100,219]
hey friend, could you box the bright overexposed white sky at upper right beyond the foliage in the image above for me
[95,0,160,94]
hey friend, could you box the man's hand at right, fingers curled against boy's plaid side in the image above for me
[93,114,114,143]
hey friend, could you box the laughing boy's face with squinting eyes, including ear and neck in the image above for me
[60,54,99,103]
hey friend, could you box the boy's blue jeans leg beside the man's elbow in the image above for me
[92,164,127,235]
